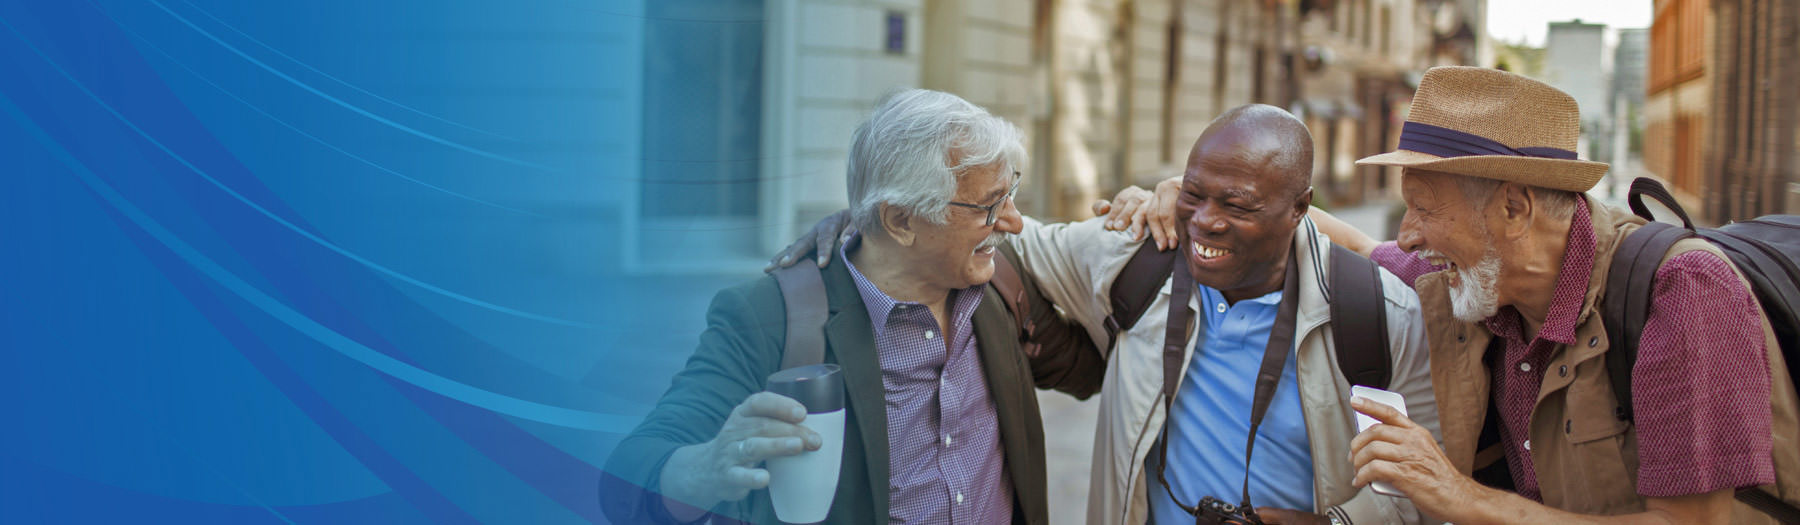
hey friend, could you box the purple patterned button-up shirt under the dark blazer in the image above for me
[839,241,1013,523]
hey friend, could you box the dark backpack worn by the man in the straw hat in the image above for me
[1600,178,1800,523]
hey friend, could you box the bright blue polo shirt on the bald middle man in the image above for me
[1145,286,1312,523]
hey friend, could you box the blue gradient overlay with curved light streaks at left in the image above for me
[0,0,745,523]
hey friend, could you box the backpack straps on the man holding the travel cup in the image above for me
[774,243,1107,399]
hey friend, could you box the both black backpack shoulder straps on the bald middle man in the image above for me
[1105,237,1393,388]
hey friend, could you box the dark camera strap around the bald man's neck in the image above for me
[1156,252,1300,523]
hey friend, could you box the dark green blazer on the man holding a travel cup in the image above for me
[599,257,1049,525]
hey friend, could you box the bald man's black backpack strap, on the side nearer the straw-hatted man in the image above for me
[1328,245,1393,388]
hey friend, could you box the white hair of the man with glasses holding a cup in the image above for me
[846,90,1024,232]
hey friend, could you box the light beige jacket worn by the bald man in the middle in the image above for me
[1013,219,1438,523]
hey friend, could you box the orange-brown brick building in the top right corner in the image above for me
[1643,0,1800,223]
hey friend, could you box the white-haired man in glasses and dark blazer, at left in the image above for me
[601,90,1048,523]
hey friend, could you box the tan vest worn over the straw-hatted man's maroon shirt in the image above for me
[1417,198,1800,523]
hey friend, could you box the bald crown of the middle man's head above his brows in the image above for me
[1188,104,1312,194]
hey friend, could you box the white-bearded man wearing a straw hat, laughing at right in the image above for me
[1314,67,1800,523]
